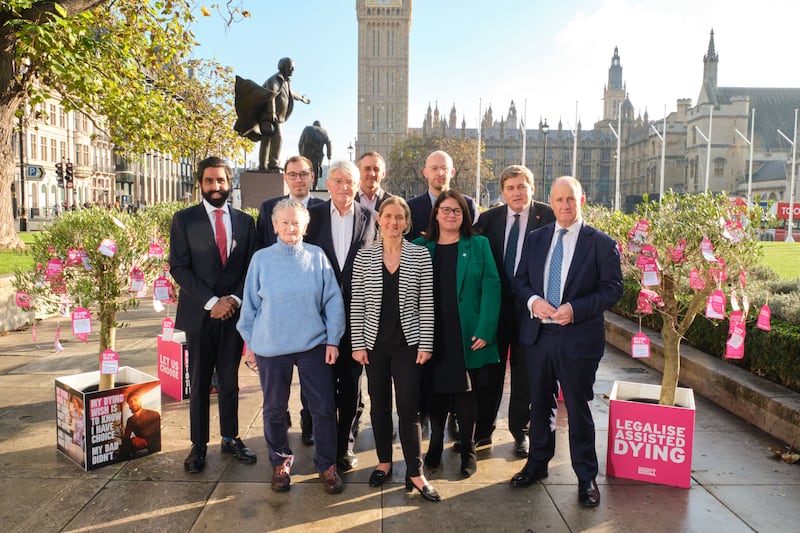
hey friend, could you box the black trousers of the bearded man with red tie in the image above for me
[186,313,244,444]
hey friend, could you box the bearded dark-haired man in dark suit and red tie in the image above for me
[169,157,258,473]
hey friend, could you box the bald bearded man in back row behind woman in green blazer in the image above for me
[406,150,478,241]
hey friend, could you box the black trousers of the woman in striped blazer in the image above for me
[366,346,422,477]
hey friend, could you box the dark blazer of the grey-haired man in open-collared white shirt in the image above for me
[303,200,377,308]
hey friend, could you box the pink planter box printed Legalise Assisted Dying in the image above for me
[606,381,695,488]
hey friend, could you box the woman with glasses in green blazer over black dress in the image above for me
[414,190,500,477]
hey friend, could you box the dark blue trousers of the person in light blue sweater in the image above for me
[256,345,336,472]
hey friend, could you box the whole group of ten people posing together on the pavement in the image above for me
[170,147,622,506]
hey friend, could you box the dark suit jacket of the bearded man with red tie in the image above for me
[169,202,258,332]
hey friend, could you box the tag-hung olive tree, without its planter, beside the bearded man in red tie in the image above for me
[14,208,168,390]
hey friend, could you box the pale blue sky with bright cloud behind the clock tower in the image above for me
[193,0,800,165]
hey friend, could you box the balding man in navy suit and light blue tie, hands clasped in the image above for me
[511,176,622,507]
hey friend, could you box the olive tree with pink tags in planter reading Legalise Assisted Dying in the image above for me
[584,192,762,487]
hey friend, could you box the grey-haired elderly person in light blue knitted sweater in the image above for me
[241,198,345,494]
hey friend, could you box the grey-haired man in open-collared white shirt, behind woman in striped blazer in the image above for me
[305,161,377,471]
